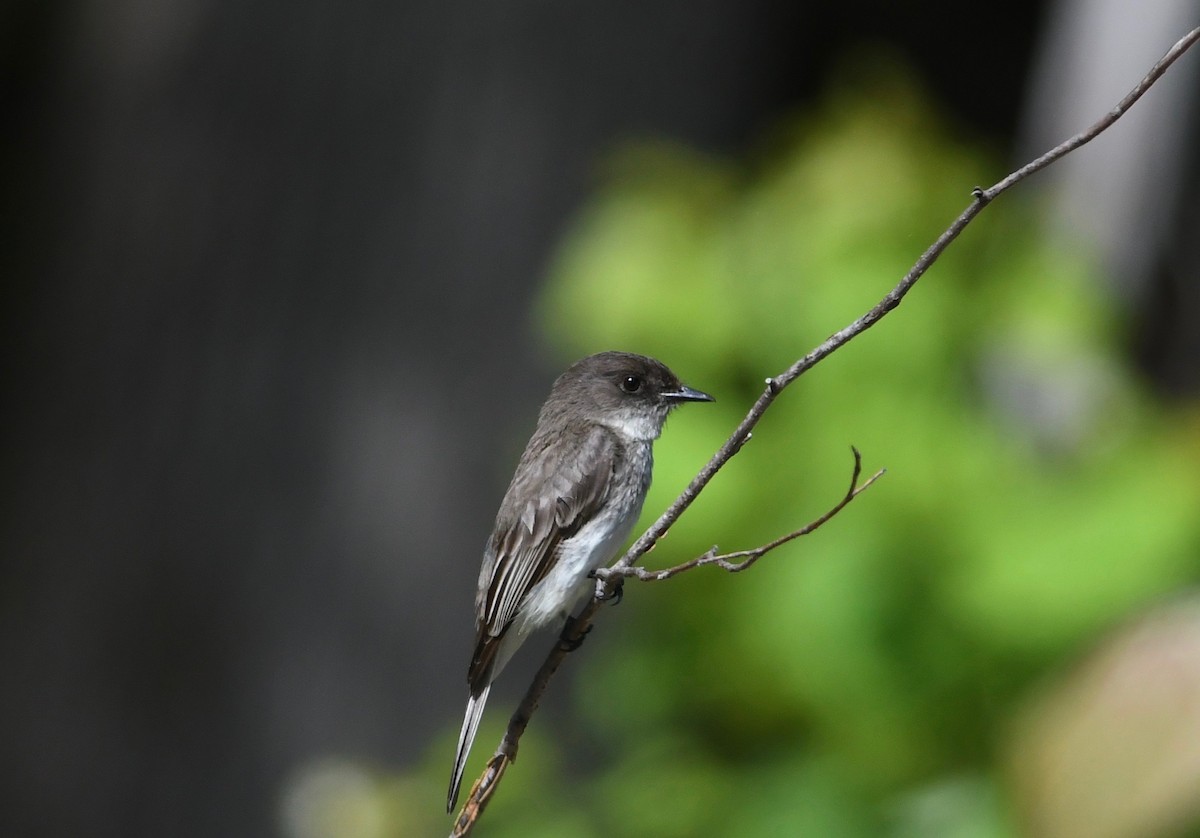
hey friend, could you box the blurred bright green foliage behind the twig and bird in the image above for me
[297,62,1200,838]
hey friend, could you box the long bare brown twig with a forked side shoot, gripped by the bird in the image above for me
[451,28,1200,838]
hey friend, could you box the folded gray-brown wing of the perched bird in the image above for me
[468,427,619,689]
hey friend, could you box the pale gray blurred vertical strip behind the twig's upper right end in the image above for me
[1014,0,1200,301]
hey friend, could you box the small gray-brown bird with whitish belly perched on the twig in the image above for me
[446,352,713,812]
